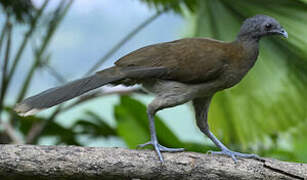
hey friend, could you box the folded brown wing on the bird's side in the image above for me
[115,38,231,83]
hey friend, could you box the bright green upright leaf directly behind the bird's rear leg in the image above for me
[115,96,183,148]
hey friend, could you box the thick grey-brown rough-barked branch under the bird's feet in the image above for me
[0,145,307,180]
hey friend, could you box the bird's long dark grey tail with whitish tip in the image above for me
[14,67,123,116]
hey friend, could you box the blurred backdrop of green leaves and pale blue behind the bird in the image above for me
[0,0,307,162]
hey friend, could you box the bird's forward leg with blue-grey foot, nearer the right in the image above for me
[193,97,261,163]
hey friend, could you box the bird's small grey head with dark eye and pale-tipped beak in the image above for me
[238,15,288,40]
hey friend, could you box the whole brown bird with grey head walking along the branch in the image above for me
[15,15,288,162]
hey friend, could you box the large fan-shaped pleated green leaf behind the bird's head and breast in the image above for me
[192,0,307,155]
